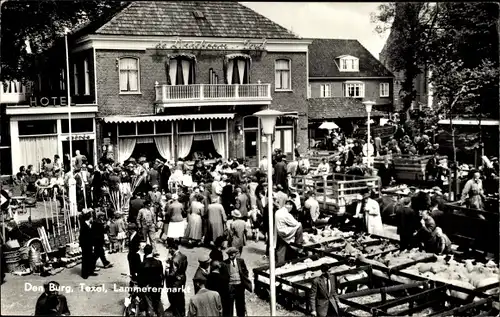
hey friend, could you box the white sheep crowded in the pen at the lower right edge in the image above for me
[402,256,500,297]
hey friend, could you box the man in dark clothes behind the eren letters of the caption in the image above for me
[137,244,164,316]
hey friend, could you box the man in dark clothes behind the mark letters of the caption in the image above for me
[165,240,188,317]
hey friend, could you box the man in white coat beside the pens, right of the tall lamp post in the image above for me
[275,200,303,264]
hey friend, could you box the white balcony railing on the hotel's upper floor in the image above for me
[155,83,271,103]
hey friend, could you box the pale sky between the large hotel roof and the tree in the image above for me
[240,2,389,59]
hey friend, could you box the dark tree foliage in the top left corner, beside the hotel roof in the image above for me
[1,0,125,80]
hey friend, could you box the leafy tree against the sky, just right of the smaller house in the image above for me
[372,2,437,117]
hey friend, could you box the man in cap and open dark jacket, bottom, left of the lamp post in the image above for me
[222,247,252,316]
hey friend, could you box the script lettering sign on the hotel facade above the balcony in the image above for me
[155,38,267,51]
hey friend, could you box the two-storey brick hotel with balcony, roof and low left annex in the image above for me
[3,1,311,170]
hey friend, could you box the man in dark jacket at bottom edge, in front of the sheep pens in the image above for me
[309,264,340,317]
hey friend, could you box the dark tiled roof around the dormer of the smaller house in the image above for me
[309,39,393,77]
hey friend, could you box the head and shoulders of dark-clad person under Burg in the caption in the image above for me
[34,281,71,316]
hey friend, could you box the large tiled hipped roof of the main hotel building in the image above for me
[73,1,299,39]
